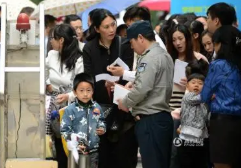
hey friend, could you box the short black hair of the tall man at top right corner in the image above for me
[207,2,237,25]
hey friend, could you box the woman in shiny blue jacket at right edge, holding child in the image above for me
[201,25,241,168]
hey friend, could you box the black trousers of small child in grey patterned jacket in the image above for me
[177,139,209,168]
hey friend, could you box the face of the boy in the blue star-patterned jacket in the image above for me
[74,82,93,103]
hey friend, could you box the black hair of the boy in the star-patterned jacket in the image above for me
[73,73,94,91]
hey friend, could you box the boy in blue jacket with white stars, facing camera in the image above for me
[61,73,106,168]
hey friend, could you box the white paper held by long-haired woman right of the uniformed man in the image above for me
[173,59,188,85]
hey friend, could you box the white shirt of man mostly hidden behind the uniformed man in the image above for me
[123,30,167,82]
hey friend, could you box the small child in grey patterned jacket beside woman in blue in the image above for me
[177,73,208,168]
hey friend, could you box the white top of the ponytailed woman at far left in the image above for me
[46,50,84,101]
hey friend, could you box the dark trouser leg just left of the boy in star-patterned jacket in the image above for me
[55,138,68,168]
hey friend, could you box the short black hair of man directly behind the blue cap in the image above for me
[123,6,151,22]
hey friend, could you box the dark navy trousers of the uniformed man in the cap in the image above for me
[135,112,173,168]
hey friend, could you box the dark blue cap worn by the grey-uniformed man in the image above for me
[123,20,154,43]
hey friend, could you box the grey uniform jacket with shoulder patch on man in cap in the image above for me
[123,43,174,116]
